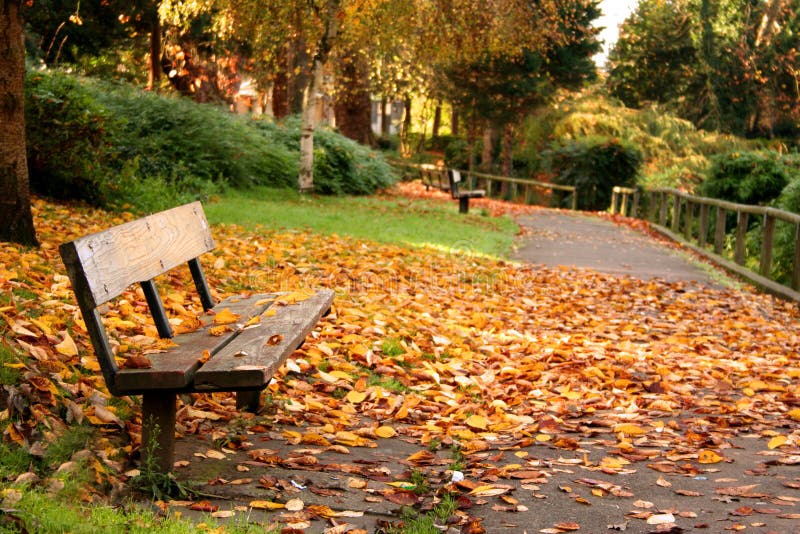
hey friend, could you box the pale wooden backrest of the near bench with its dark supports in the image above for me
[59,202,214,392]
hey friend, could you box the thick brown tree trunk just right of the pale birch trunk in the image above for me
[334,51,375,145]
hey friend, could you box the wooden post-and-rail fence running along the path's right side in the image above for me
[611,187,800,302]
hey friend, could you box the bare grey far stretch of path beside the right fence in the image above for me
[514,210,716,286]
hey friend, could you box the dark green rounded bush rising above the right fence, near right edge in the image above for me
[700,154,800,205]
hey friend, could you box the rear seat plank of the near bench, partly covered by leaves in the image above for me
[115,294,275,395]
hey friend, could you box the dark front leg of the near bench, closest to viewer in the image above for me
[142,392,177,473]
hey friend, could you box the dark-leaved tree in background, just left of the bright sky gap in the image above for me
[438,0,600,172]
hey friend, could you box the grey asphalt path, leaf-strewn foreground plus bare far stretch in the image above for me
[164,210,800,534]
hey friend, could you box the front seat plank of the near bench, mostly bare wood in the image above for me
[194,289,333,391]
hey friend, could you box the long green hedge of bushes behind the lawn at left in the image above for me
[21,71,396,211]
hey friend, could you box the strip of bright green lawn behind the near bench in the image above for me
[204,187,517,257]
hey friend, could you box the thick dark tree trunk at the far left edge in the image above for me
[0,0,39,246]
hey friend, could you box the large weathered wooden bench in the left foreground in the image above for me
[60,202,333,472]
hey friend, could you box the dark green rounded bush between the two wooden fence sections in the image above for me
[545,137,642,210]
